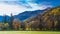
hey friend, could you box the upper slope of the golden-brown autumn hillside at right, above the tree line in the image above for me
[28,6,60,19]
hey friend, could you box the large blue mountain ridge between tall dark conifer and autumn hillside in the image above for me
[14,10,45,21]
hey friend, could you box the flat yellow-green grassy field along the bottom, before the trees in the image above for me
[0,31,60,34]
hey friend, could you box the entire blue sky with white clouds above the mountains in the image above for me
[0,0,60,16]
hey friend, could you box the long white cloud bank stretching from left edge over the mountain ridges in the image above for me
[0,2,51,16]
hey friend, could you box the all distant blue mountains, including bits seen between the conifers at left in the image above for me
[0,10,45,22]
